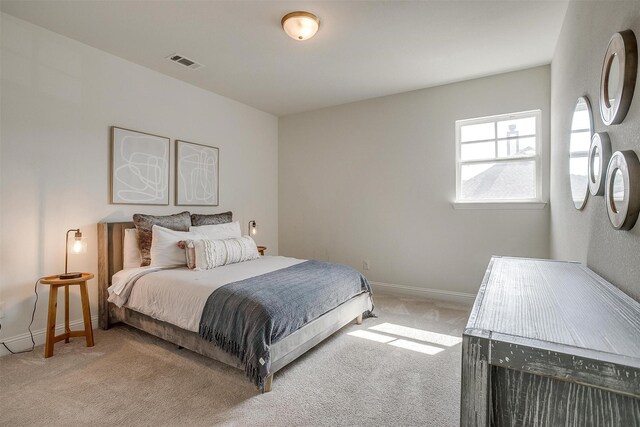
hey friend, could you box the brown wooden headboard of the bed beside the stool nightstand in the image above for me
[98,222,135,329]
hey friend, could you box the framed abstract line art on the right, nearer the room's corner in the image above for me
[175,140,220,206]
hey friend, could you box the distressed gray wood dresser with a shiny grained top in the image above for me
[460,257,640,427]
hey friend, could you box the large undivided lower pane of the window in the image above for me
[460,160,537,200]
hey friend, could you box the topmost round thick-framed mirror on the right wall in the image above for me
[600,30,638,126]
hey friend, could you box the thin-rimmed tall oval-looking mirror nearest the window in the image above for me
[569,96,593,209]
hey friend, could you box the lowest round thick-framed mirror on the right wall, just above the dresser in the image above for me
[605,150,640,230]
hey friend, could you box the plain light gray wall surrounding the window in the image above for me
[278,66,550,293]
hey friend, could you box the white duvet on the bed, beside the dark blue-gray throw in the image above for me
[108,256,305,332]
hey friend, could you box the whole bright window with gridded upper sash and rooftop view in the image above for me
[456,110,542,203]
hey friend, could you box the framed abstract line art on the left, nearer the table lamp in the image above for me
[110,126,171,205]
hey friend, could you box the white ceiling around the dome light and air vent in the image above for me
[0,0,567,115]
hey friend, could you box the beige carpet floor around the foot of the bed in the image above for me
[0,295,470,426]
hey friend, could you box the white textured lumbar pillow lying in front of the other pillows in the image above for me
[190,236,260,270]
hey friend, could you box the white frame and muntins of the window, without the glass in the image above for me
[453,110,546,209]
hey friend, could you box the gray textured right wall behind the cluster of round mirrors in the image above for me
[551,1,640,300]
